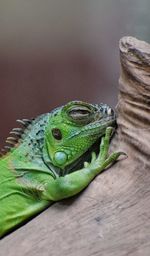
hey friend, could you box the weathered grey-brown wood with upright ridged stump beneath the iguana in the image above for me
[0,37,150,256]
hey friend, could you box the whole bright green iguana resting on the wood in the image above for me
[0,101,123,237]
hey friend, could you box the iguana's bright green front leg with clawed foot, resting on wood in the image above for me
[43,127,124,201]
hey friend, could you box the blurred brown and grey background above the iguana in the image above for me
[0,0,150,146]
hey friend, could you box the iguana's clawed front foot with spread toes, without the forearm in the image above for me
[84,127,127,174]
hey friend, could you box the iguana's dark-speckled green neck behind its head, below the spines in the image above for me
[3,113,50,172]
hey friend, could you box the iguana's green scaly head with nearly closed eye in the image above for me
[44,101,115,172]
